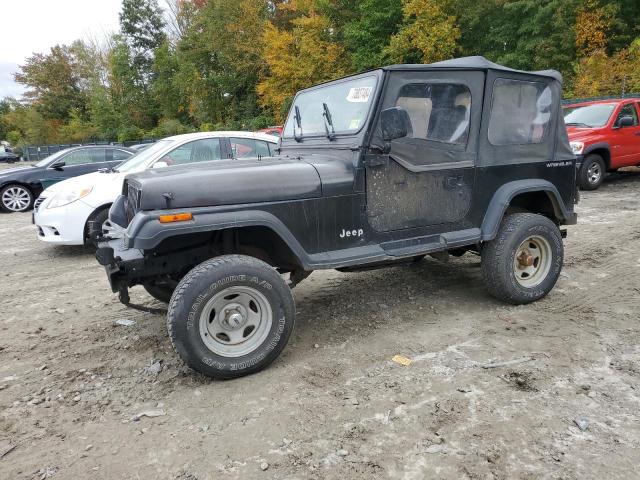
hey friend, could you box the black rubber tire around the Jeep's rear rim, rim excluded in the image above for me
[482,213,564,305]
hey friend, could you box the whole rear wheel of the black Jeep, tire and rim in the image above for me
[482,213,564,305]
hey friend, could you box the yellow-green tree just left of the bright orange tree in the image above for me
[176,0,268,128]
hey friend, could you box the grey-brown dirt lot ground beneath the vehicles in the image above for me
[0,166,640,480]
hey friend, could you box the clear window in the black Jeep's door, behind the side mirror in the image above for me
[395,83,471,145]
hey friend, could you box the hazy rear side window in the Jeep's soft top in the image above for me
[489,78,553,145]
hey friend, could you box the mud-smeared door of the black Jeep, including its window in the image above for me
[365,70,485,232]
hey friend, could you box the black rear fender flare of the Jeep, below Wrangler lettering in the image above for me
[481,179,576,242]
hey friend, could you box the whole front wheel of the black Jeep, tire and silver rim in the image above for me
[167,255,295,378]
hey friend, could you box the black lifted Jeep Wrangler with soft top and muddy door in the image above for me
[96,57,577,378]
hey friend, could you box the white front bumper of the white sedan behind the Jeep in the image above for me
[33,200,94,245]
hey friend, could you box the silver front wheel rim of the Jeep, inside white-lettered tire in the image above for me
[200,285,273,357]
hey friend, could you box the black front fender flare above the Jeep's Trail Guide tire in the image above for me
[125,209,311,269]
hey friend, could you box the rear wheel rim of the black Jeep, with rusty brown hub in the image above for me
[513,235,551,288]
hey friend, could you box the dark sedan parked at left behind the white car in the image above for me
[0,145,136,212]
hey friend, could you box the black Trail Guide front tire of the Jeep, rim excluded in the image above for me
[167,255,295,379]
